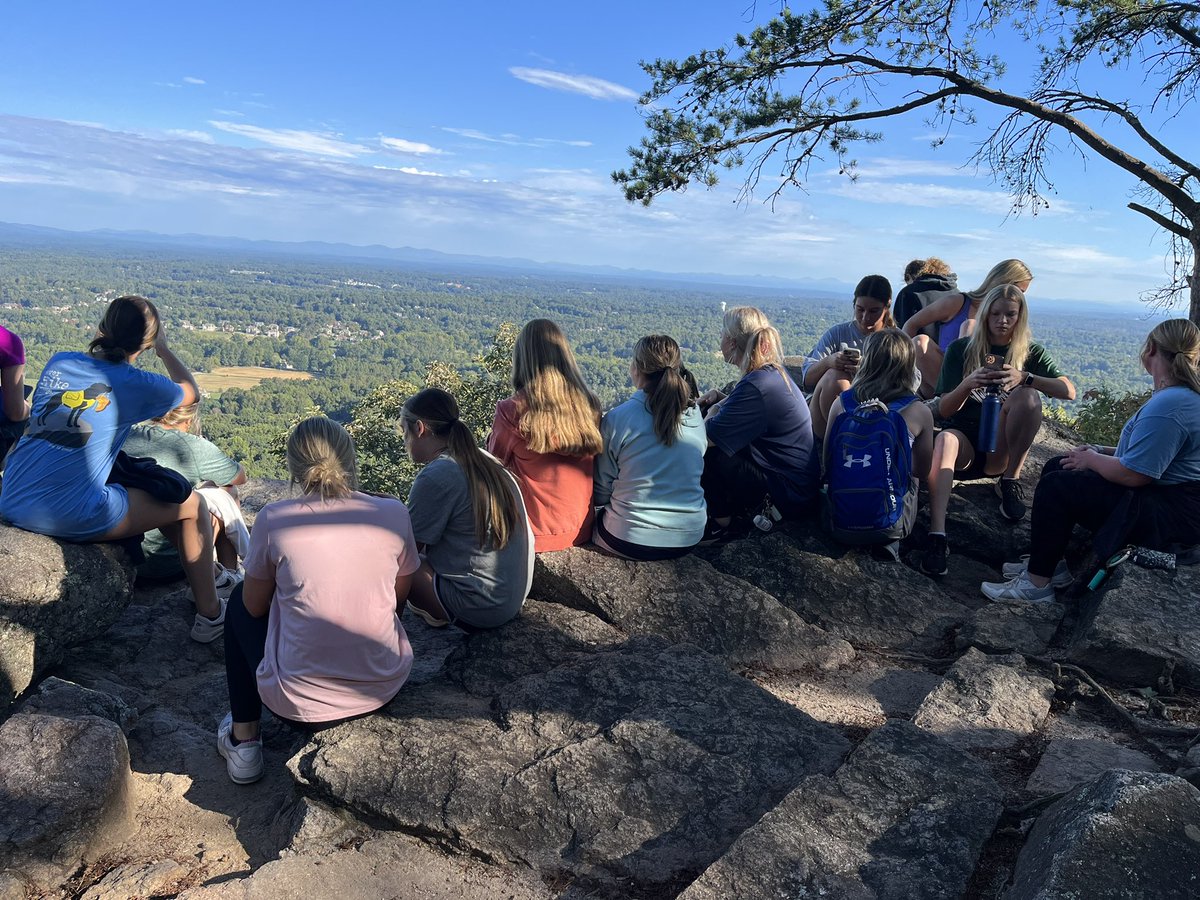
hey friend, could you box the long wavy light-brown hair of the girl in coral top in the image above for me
[512,319,604,456]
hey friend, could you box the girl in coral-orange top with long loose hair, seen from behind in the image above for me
[487,319,604,553]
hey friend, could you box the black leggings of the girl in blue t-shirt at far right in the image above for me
[1030,456,1200,578]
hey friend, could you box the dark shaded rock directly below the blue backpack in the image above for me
[713,526,971,655]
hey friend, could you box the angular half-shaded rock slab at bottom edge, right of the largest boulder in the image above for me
[680,722,1002,900]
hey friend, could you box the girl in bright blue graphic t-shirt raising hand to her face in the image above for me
[0,296,224,643]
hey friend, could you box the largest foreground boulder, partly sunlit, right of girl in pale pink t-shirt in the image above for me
[288,604,850,896]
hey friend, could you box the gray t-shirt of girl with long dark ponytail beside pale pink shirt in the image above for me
[408,456,533,628]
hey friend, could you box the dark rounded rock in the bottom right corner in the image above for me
[1006,770,1200,900]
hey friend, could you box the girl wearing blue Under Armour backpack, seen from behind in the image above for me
[822,328,934,558]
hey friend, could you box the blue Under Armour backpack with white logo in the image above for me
[826,390,917,545]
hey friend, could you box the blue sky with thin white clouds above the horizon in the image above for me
[0,0,1198,301]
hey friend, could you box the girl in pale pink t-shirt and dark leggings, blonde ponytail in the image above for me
[217,416,421,784]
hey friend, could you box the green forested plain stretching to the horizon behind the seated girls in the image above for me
[0,237,1150,478]
